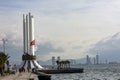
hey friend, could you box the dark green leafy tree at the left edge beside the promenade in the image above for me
[0,52,9,75]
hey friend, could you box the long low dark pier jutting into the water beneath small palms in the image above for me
[36,68,84,74]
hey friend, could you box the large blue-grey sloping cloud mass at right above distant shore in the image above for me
[88,33,120,61]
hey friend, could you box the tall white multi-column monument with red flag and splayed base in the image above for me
[20,13,43,69]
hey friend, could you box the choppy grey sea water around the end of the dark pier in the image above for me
[51,64,120,80]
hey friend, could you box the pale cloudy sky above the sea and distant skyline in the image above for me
[0,0,120,61]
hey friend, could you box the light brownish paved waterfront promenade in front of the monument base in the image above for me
[0,72,38,80]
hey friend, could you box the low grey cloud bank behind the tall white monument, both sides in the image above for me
[0,33,64,62]
